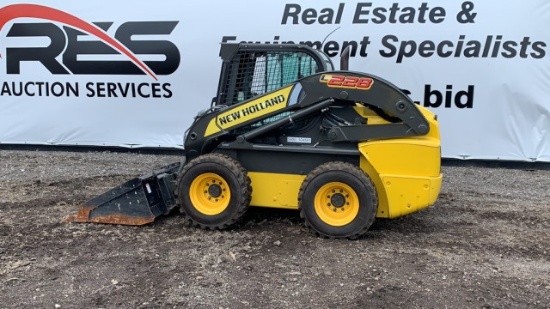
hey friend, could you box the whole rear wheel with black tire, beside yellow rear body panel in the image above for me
[298,162,378,239]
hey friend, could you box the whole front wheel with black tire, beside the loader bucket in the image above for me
[176,153,252,229]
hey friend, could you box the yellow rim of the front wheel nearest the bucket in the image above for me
[189,173,231,216]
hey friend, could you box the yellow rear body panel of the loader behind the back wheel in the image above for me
[358,107,442,218]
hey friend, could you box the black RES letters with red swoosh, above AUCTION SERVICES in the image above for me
[0,4,180,80]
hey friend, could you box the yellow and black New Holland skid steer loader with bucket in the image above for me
[66,43,442,239]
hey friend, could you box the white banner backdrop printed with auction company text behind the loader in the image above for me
[0,0,550,162]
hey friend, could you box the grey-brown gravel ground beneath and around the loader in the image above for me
[0,150,550,308]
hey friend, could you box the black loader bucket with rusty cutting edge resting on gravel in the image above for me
[64,163,180,225]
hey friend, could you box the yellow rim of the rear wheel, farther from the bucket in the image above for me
[314,182,359,226]
